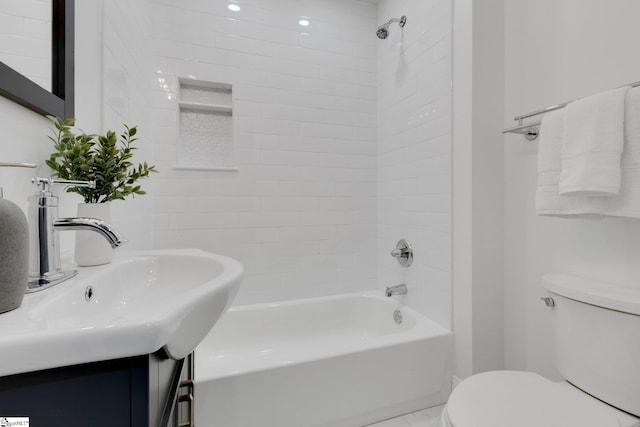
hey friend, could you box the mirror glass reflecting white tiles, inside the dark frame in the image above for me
[0,0,52,90]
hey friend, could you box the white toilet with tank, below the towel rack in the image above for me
[441,274,640,427]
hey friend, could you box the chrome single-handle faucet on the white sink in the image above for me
[26,178,127,292]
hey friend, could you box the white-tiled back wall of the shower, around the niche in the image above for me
[152,0,378,303]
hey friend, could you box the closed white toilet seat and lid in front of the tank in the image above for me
[442,371,640,427]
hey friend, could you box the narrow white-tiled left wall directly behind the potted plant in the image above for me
[104,0,158,250]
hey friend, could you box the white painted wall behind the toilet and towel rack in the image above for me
[504,0,640,377]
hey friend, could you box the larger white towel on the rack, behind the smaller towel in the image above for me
[536,87,640,218]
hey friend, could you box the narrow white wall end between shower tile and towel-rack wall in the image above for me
[453,0,504,378]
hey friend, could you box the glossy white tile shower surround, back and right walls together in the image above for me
[150,0,451,325]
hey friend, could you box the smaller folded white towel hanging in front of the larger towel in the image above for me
[559,87,628,196]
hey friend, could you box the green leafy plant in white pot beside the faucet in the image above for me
[45,116,156,266]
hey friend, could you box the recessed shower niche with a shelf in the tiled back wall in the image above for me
[175,78,238,171]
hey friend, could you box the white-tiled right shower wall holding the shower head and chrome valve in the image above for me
[377,0,452,327]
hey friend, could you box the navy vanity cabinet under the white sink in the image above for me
[0,354,184,427]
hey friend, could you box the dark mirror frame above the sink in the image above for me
[0,0,75,118]
